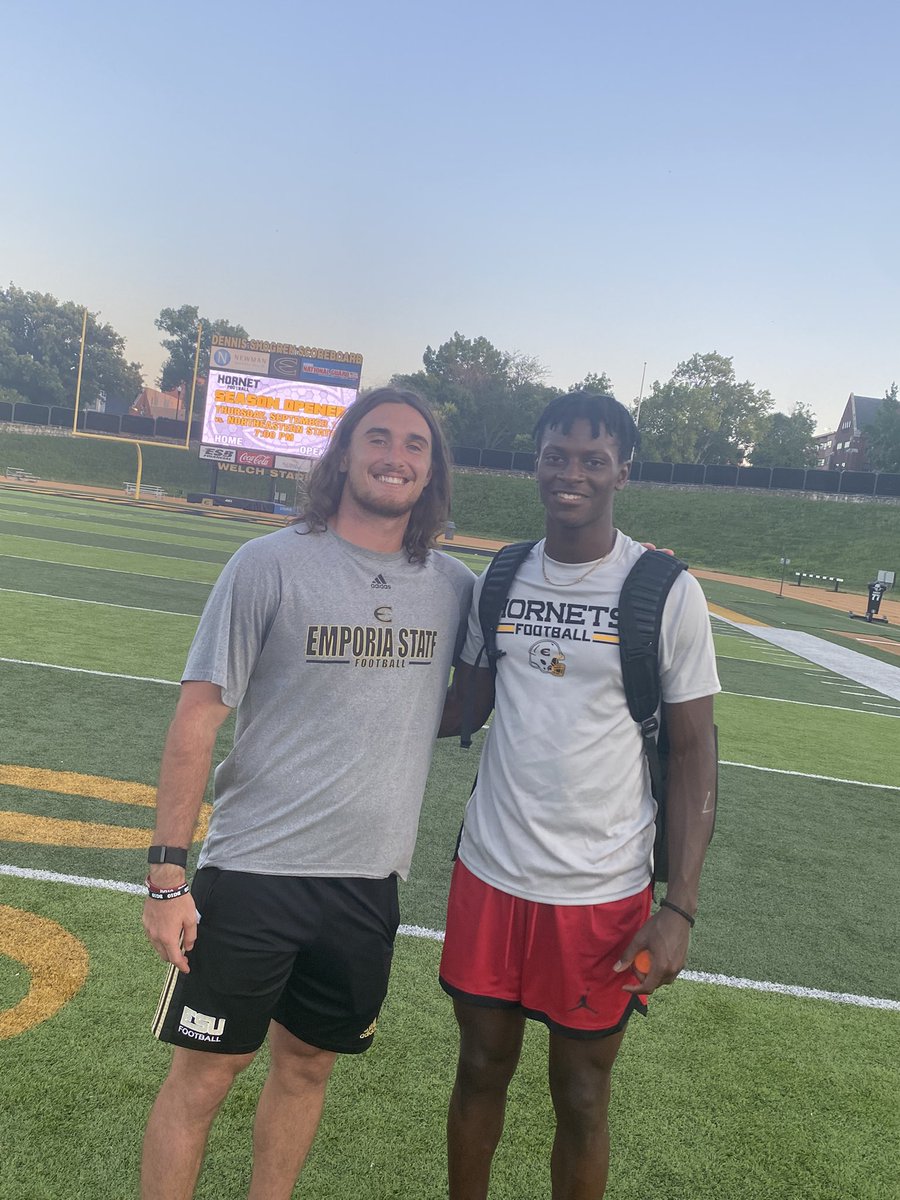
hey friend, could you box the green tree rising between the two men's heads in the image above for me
[391,332,559,450]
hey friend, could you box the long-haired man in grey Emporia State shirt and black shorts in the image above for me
[142,388,473,1200]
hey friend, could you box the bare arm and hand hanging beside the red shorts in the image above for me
[620,696,716,994]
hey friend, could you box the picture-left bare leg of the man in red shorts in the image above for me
[446,1000,524,1200]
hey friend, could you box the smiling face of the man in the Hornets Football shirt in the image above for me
[538,418,629,533]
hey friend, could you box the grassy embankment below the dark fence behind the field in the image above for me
[0,431,900,592]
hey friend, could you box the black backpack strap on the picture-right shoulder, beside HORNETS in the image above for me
[619,550,688,809]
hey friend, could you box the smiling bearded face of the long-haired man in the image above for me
[341,403,431,517]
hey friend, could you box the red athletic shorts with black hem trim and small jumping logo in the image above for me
[440,859,652,1038]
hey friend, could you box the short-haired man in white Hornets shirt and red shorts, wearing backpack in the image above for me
[440,392,719,1200]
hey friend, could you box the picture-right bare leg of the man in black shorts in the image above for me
[247,1021,337,1200]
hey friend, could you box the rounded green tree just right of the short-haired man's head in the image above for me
[632,354,773,463]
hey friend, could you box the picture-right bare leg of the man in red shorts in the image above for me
[550,1030,625,1200]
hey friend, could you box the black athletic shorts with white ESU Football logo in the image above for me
[152,866,400,1054]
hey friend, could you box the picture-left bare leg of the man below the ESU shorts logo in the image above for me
[140,1046,256,1200]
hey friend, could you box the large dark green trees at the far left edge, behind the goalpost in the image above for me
[0,283,143,409]
